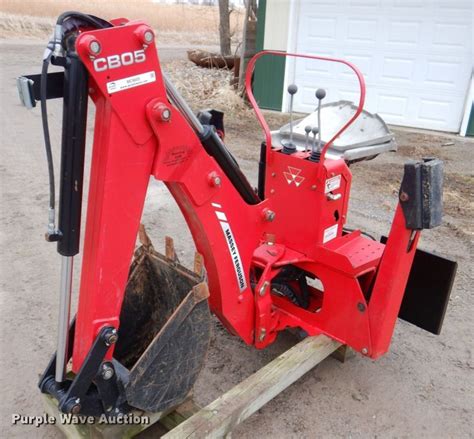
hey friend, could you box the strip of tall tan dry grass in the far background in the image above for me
[0,0,243,44]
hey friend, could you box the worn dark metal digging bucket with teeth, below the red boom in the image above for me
[114,228,210,412]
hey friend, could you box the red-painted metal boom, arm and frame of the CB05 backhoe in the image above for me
[73,20,424,372]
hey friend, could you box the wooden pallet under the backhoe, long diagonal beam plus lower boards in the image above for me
[45,335,349,439]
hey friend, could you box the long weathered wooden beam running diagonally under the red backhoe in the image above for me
[162,335,341,439]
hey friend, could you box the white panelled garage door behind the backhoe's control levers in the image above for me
[287,0,474,132]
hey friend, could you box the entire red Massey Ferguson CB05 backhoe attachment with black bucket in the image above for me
[18,12,456,422]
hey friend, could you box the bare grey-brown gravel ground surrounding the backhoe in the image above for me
[0,40,474,438]
